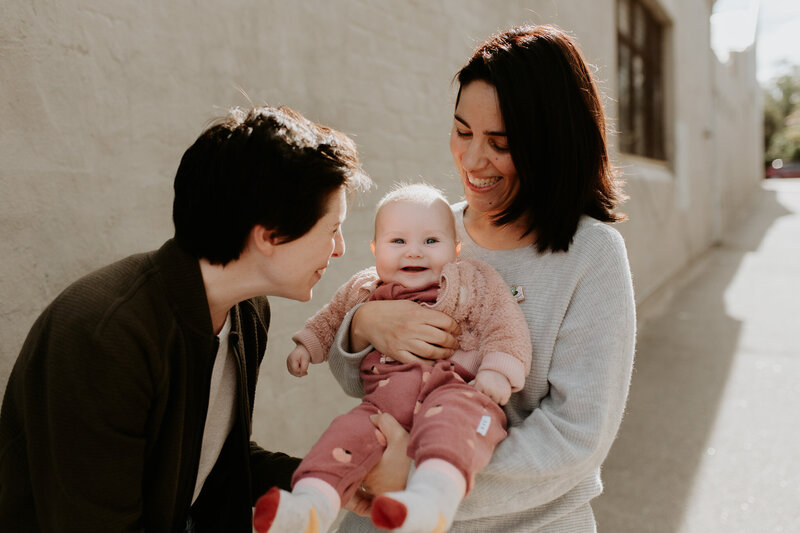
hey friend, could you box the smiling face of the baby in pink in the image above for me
[372,200,459,289]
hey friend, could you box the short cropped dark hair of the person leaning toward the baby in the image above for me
[172,106,372,265]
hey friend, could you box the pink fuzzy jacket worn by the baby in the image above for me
[292,259,532,392]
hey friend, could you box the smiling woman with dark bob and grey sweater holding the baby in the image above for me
[330,25,636,533]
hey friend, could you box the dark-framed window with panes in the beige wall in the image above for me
[616,0,667,160]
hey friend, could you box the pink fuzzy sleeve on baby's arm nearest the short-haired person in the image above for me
[292,267,378,364]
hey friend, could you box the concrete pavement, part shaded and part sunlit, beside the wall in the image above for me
[593,179,800,533]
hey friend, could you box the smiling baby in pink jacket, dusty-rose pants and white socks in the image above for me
[254,184,531,533]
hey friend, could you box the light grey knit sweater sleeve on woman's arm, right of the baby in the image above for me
[457,225,636,520]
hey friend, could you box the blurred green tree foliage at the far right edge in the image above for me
[764,67,800,164]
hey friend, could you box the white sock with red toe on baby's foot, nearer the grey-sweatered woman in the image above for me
[372,459,467,533]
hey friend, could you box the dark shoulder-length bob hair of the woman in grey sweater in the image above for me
[456,25,625,252]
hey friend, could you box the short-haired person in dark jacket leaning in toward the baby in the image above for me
[0,107,384,533]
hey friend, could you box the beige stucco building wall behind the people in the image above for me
[0,0,755,454]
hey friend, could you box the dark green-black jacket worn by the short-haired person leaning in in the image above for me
[0,241,299,533]
